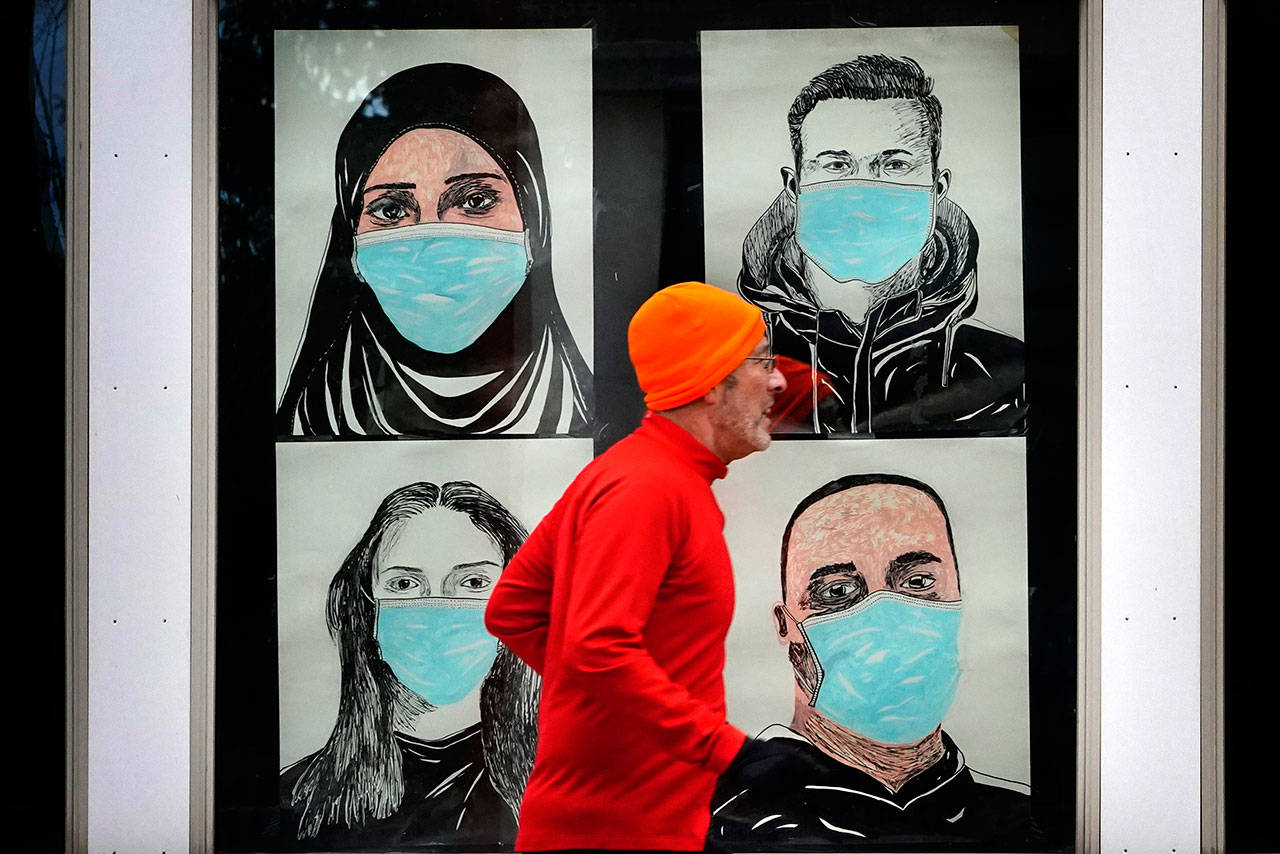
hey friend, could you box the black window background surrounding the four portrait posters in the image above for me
[214,0,1079,850]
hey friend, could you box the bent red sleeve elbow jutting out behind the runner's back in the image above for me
[484,511,556,675]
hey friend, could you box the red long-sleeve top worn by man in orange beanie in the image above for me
[485,414,746,851]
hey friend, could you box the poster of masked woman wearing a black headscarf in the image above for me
[274,29,593,439]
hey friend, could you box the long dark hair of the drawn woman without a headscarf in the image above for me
[289,480,540,839]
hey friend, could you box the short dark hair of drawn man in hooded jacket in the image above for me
[787,54,942,169]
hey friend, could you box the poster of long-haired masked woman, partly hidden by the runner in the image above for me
[276,439,591,849]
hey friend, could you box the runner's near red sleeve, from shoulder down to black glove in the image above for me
[562,481,746,773]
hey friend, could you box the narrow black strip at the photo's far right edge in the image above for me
[1222,3,1280,854]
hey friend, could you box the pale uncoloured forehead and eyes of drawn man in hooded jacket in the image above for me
[799,99,934,187]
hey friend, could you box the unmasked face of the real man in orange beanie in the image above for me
[710,338,787,462]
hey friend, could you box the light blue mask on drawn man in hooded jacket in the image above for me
[796,178,933,284]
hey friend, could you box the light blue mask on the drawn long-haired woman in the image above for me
[375,597,498,705]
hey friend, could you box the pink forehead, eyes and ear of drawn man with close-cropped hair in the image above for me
[774,484,960,635]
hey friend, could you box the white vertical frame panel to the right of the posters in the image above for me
[1098,0,1203,851]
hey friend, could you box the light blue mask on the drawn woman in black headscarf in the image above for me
[355,223,532,353]
